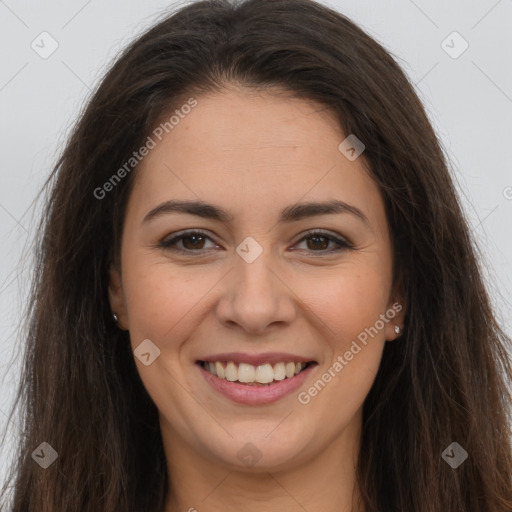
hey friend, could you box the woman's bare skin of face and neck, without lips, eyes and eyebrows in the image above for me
[110,86,405,512]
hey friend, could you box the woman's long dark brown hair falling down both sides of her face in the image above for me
[0,0,512,512]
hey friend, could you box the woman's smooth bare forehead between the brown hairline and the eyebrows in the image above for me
[127,88,383,228]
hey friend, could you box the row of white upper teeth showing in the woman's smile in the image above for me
[203,361,306,384]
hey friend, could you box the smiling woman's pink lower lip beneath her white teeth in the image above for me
[196,363,317,405]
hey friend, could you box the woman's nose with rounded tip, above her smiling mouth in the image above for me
[216,251,296,334]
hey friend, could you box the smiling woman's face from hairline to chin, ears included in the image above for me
[110,88,404,470]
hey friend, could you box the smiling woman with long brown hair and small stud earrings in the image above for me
[1,0,512,512]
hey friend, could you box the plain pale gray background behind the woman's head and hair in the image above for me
[0,0,512,496]
